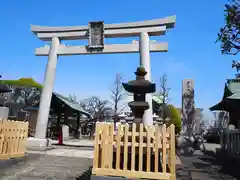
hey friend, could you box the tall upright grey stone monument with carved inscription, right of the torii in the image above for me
[181,79,197,136]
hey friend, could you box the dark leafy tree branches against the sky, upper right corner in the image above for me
[217,0,240,55]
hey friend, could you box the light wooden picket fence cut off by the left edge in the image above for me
[0,120,28,160]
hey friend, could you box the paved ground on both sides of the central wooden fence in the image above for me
[0,147,240,180]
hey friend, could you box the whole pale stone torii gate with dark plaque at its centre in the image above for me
[31,16,176,149]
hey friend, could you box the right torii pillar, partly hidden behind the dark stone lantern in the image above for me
[139,32,153,125]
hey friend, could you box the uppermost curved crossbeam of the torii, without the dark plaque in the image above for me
[31,16,176,41]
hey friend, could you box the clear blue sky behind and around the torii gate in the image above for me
[0,0,232,119]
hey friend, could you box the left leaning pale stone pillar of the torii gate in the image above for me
[35,37,60,139]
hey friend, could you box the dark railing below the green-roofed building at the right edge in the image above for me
[221,129,240,155]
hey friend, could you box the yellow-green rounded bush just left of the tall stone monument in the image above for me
[166,104,182,134]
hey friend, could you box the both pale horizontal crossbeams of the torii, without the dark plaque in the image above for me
[31,16,176,56]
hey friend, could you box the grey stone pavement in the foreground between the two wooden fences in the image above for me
[0,154,92,180]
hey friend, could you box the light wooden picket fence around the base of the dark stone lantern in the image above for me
[92,123,176,180]
